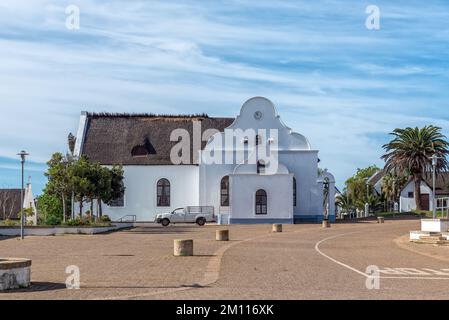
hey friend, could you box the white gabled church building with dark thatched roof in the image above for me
[75,97,335,224]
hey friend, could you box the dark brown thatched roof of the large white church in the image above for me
[81,113,234,165]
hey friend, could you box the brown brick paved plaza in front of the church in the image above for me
[0,219,449,299]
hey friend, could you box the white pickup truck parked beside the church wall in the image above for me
[155,206,216,227]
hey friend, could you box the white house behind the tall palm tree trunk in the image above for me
[399,172,449,212]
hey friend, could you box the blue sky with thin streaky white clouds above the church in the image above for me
[0,0,449,193]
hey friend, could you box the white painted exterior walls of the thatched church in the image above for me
[76,97,333,221]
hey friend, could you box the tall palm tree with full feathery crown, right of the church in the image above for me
[382,125,449,210]
